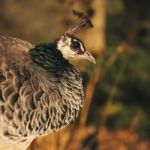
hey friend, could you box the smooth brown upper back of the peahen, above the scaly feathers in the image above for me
[0,36,33,67]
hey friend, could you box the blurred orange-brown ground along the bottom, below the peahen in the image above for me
[30,127,150,150]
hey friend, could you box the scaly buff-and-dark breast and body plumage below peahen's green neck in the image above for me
[0,59,83,142]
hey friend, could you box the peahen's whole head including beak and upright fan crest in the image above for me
[57,10,95,63]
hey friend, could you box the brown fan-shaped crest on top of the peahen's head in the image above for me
[66,10,93,35]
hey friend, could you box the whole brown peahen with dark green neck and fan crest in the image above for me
[0,10,95,150]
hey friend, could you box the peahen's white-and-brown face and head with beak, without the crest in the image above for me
[57,34,95,63]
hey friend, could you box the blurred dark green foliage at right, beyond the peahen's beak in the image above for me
[86,2,150,136]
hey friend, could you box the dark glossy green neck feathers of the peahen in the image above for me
[29,42,69,74]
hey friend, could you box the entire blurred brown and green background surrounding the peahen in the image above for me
[0,0,150,150]
